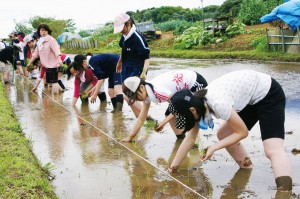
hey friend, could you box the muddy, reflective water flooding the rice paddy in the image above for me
[5,58,300,199]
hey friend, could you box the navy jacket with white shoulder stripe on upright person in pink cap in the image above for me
[119,31,150,68]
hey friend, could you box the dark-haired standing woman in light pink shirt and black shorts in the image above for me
[27,24,62,93]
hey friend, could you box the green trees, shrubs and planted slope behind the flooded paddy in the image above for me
[10,0,299,61]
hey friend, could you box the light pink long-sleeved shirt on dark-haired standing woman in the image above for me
[32,35,62,68]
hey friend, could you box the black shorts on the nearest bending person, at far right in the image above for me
[238,78,286,140]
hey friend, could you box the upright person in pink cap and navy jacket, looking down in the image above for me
[114,13,150,117]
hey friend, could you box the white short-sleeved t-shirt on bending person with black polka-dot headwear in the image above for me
[206,70,271,120]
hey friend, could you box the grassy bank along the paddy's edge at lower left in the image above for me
[0,81,57,198]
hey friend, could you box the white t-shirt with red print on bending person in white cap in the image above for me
[145,69,197,103]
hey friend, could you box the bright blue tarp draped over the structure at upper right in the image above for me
[260,0,300,30]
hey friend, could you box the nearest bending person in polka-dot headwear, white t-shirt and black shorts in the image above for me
[171,70,292,191]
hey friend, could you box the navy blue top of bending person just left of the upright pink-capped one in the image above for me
[89,54,120,80]
